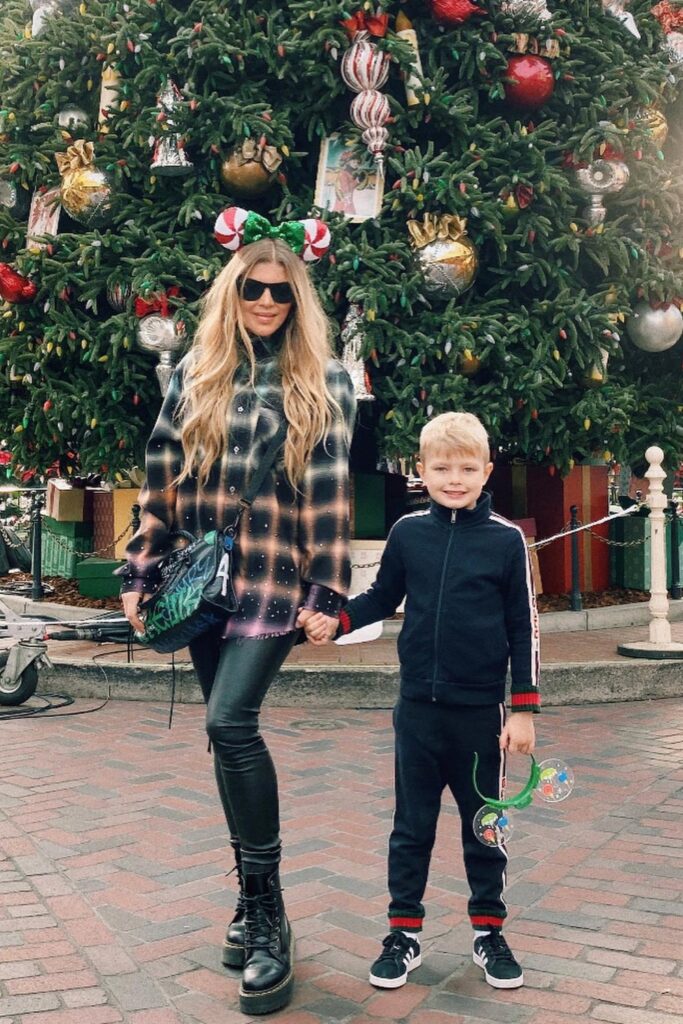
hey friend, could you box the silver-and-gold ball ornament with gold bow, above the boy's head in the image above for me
[408,213,479,301]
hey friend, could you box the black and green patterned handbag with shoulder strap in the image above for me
[135,423,287,653]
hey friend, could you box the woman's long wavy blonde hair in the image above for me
[177,239,341,487]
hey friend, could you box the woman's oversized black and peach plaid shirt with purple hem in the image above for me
[117,354,355,637]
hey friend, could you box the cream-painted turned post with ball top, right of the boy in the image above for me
[616,444,683,658]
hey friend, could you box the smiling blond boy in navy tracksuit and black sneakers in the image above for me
[299,413,540,988]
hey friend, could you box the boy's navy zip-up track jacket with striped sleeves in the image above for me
[340,494,540,712]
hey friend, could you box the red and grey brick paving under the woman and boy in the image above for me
[0,700,683,1024]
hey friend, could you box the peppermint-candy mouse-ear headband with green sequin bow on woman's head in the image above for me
[214,206,332,263]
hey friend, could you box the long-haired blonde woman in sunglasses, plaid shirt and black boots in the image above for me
[119,211,355,1014]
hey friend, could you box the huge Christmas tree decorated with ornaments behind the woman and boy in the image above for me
[0,0,683,483]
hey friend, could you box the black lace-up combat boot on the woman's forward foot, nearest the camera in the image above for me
[240,867,294,1015]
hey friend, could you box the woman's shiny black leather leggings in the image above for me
[189,632,297,873]
